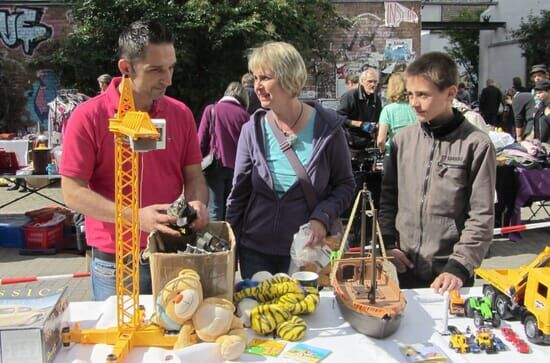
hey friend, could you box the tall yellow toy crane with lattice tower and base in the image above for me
[63,77,177,363]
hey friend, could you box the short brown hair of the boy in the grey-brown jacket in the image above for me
[405,52,458,91]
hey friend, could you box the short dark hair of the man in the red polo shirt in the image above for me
[118,20,174,62]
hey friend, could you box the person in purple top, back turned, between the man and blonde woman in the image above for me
[198,82,250,221]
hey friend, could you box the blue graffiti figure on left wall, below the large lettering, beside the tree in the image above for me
[25,69,59,131]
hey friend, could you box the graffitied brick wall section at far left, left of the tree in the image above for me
[0,1,71,131]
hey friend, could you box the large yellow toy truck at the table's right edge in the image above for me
[475,247,550,344]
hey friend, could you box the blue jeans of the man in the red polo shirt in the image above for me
[90,256,152,301]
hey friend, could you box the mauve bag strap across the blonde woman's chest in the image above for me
[265,111,317,211]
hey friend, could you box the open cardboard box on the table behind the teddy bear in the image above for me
[149,222,236,301]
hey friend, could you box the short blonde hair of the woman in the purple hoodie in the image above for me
[248,42,307,97]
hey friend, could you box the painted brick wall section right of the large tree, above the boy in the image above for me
[302,1,421,98]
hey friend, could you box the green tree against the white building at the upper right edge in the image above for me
[512,10,550,70]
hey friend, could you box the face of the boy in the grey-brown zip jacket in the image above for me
[407,76,457,122]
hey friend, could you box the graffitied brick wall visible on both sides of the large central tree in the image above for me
[0,1,421,131]
